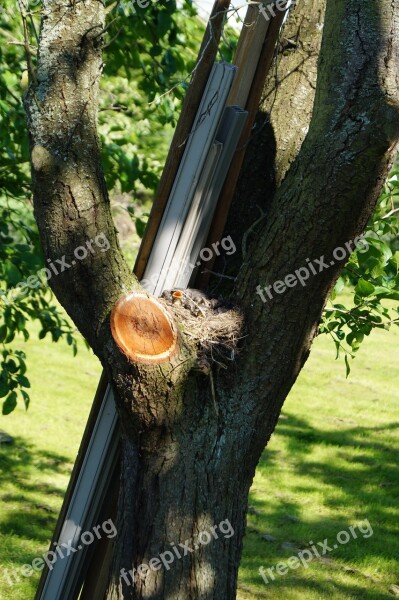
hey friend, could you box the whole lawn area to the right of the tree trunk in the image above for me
[238,329,399,600]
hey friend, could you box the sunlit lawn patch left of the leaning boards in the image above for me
[0,328,101,600]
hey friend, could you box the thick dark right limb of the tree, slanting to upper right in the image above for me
[235,0,399,431]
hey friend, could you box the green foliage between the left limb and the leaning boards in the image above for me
[99,0,203,201]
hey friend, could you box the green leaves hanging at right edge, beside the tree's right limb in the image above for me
[319,166,399,375]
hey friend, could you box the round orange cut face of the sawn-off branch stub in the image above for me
[111,292,178,365]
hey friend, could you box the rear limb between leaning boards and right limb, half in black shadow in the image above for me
[217,0,326,280]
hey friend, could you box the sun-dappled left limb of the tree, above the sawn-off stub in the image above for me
[25,0,139,353]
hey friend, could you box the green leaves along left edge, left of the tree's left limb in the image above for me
[0,1,80,414]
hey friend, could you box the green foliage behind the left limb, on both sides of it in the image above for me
[0,0,209,414]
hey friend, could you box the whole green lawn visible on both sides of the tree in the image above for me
[0,312,399,600]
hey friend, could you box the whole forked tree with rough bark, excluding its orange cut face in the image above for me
[25,0,399,599]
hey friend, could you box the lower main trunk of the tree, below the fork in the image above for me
[107,404,254,600]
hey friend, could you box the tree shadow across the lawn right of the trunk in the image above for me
[240,414,399,600]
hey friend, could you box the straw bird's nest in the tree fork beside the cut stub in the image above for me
[161,299,244,371]
